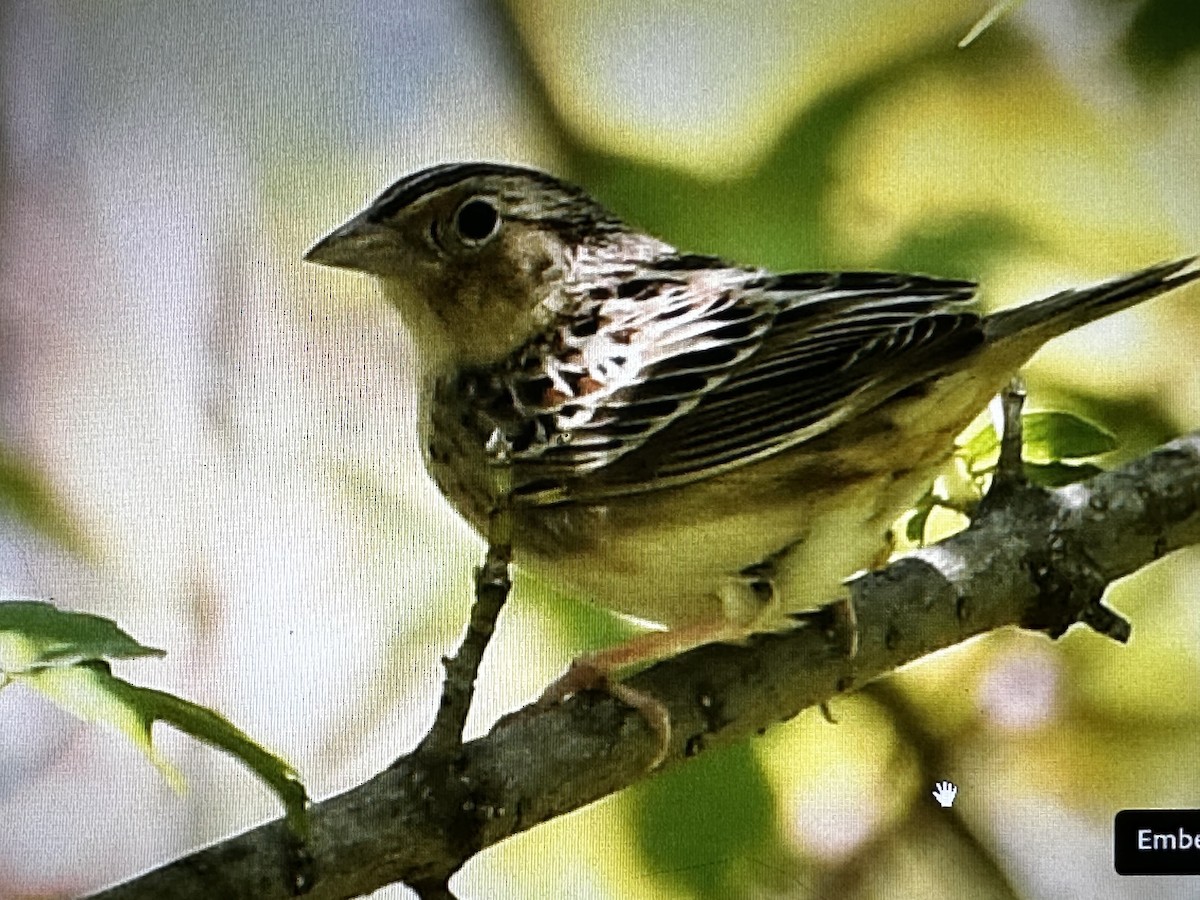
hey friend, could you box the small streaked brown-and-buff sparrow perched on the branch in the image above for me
[305,162,1200,734]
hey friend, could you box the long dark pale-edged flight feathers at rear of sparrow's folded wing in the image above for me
[647,272,984,482]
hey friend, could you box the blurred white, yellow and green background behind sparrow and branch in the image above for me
[0,0,1200,899]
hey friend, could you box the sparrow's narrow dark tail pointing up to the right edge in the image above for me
[984,257,1200,352]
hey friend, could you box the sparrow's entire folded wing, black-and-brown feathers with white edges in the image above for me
[472,264,983,503]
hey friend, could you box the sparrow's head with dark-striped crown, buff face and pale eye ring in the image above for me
[305,163,657,365]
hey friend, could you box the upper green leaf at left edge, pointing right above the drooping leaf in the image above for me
[0,600,164,674]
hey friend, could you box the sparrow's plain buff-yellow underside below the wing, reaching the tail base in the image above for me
[451,362,1007,631]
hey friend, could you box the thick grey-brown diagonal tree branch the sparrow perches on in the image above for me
[87,432,1200,900]
